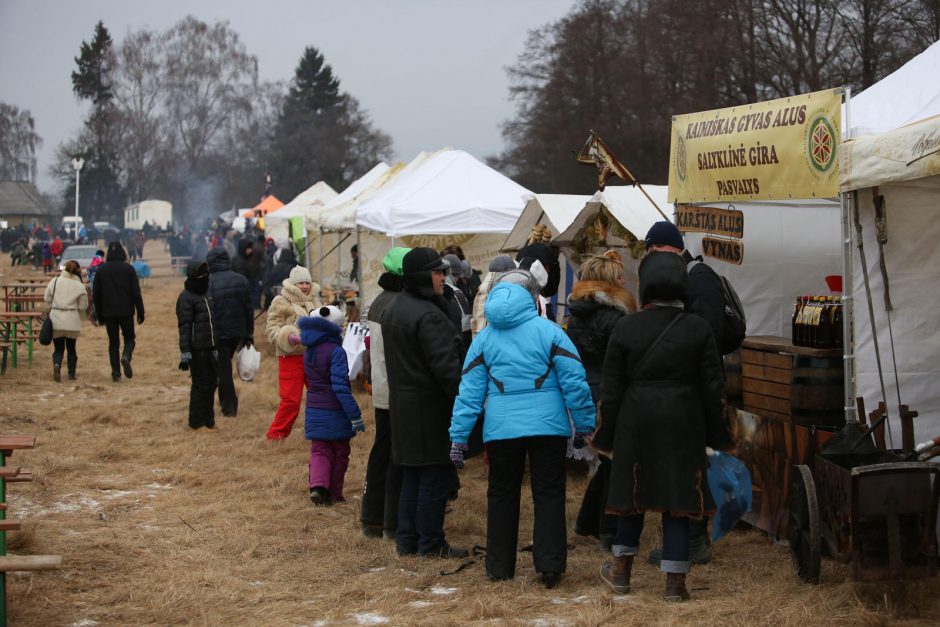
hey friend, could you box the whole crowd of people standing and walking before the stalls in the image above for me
[14,222,734,601]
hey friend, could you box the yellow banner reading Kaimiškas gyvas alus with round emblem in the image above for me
[669,90,842,203]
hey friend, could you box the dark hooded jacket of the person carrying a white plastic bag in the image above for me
[206,248,255,340]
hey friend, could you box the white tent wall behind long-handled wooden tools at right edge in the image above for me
[853,176,940,448]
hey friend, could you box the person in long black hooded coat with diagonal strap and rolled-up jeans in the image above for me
[593,251,733,600]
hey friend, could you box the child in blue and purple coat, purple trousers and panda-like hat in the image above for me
[288,307,366,505]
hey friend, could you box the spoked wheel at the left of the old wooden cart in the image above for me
[788,465,822,583]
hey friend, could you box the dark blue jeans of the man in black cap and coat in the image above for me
[395,464,455,555]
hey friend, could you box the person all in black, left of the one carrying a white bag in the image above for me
[176,261,217,430]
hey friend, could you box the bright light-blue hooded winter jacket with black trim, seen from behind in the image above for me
[450,283,595,444]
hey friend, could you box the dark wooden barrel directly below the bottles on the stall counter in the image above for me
[790,355,845,428]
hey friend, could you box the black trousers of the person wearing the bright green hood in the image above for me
[359,407,401,534]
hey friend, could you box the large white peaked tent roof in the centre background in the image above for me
[356,150,531,237]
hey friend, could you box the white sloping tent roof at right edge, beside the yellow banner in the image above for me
[843,41,940,137]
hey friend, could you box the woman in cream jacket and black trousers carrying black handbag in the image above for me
[43,259,88,383]
